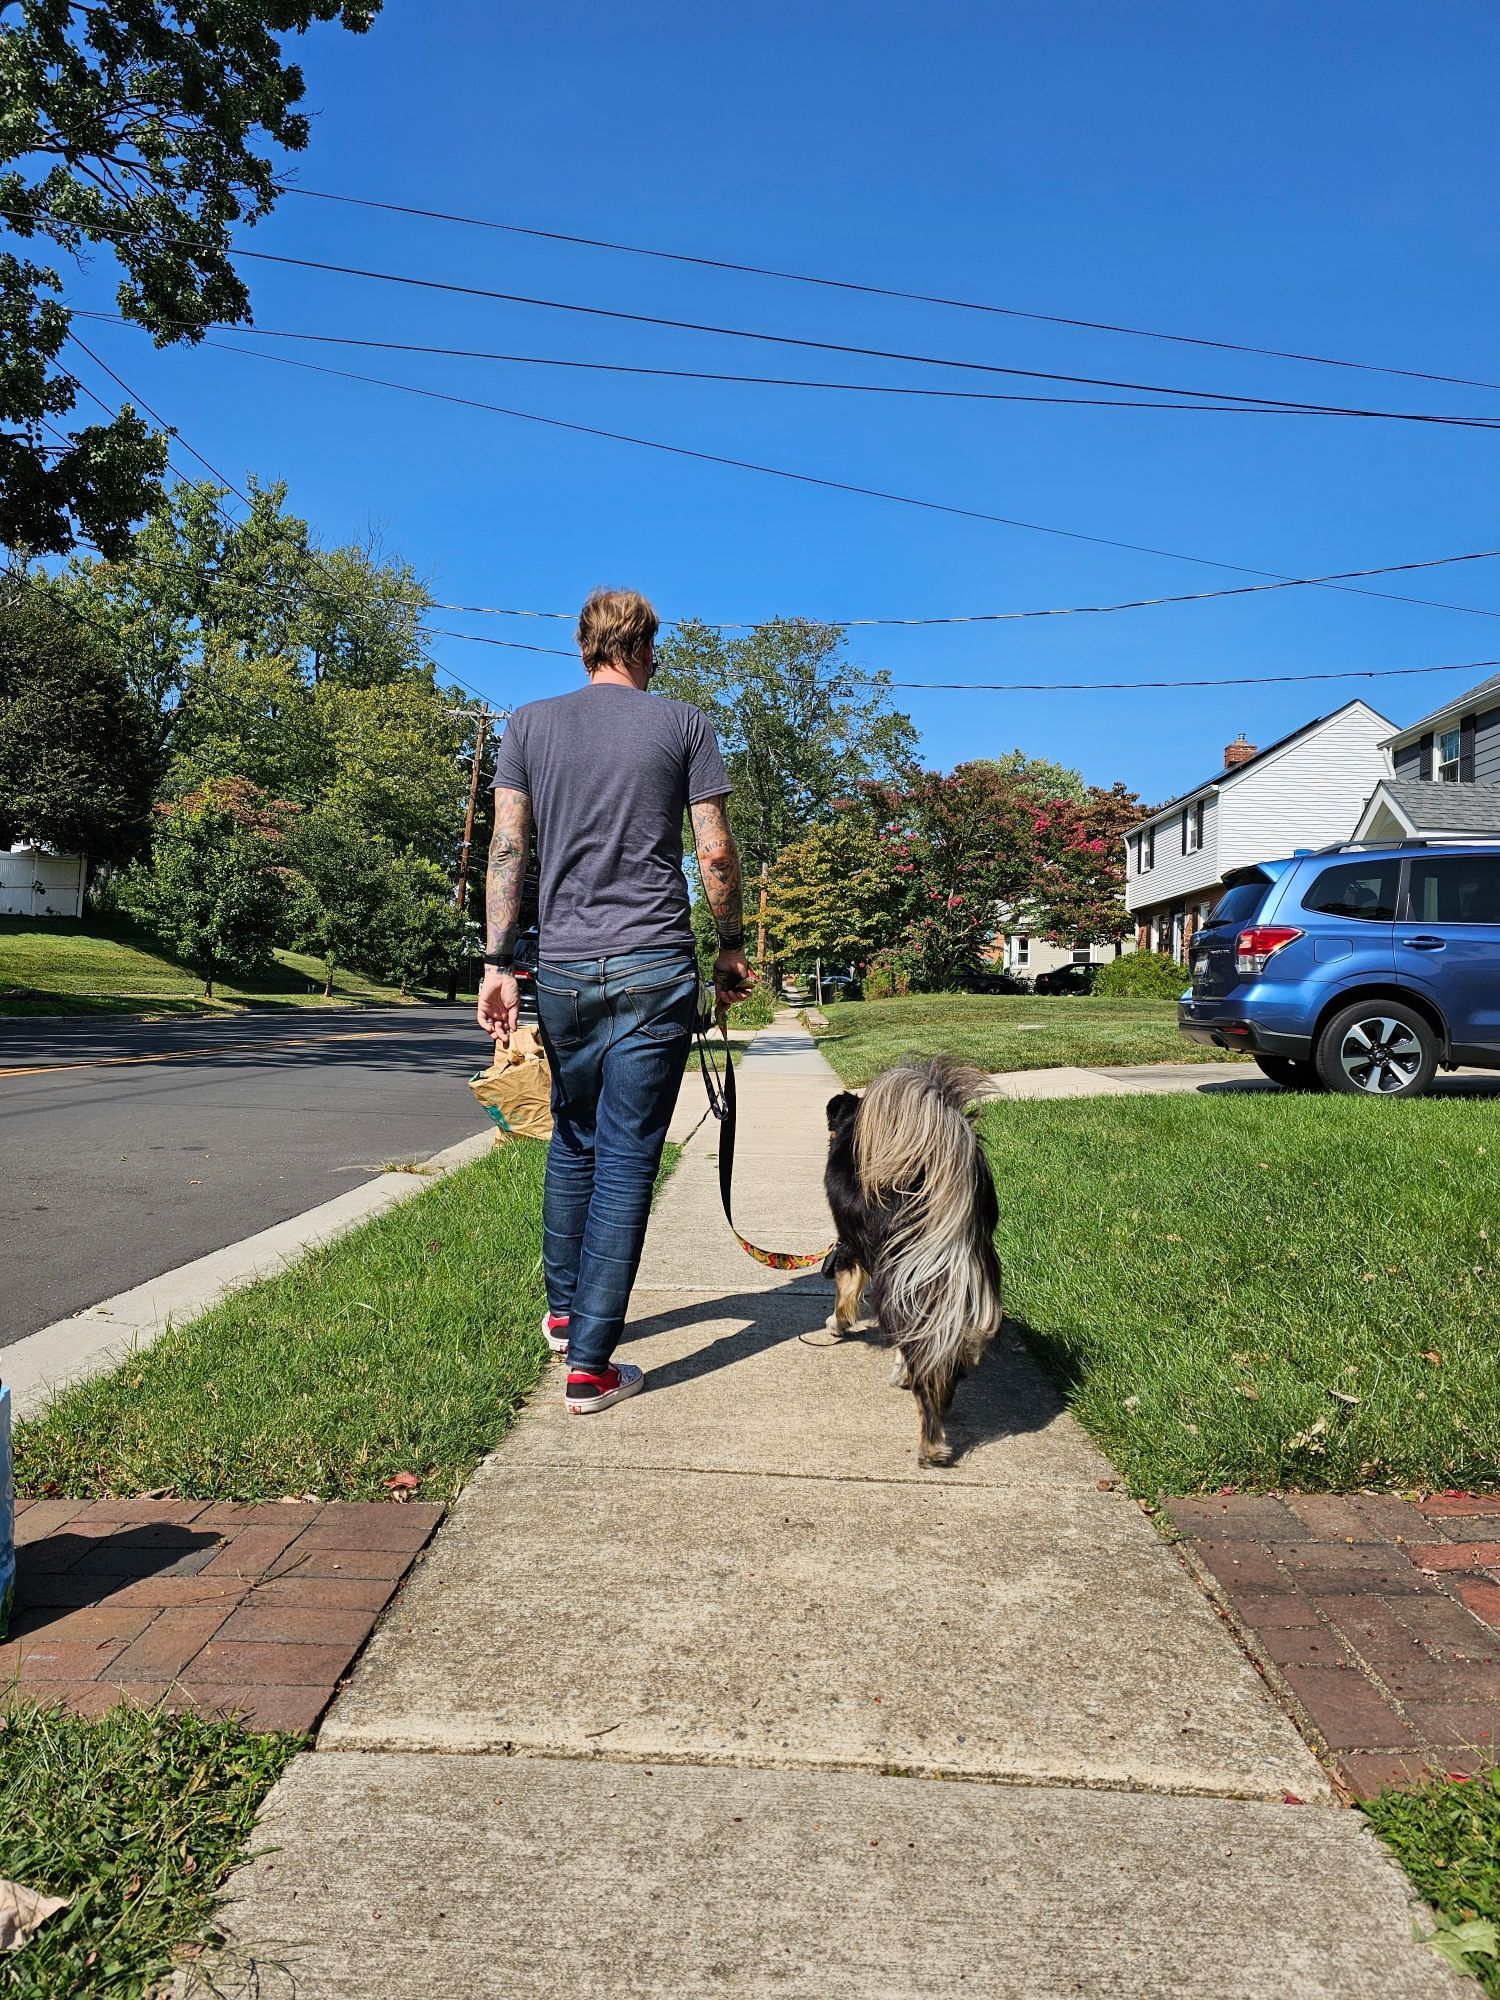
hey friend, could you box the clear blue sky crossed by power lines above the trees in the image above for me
[61,0,1500,798]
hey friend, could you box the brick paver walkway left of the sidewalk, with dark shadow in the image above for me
[0,1500,442,1730]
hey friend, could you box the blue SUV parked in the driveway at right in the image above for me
[1178,840,1500,1098]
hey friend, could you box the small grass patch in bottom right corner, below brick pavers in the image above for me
[1362,1770,1500,2000]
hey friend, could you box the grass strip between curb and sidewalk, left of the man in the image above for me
[16,1140,548,1500]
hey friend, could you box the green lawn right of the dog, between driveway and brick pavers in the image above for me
[982,1092,1500,1496]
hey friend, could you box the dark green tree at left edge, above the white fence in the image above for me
[0,578,160,862]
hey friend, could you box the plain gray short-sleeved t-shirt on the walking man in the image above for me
[494,684,730,958]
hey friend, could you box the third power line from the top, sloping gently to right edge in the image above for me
[64,308,1500,430]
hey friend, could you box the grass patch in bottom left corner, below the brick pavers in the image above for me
[0,1700,300,2000]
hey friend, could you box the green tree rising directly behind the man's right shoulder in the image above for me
[654,618,916,948]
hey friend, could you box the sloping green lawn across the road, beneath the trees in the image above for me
[0,916,444,1014]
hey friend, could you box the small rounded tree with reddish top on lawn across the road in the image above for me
[120,778,292,1000]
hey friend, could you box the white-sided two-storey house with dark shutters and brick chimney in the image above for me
[1126,700,1394,960]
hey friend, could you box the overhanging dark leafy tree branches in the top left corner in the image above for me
[0,0,380,556]
